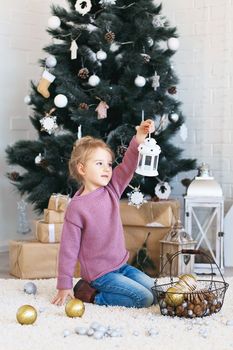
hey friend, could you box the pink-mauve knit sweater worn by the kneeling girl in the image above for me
[57,137,138,289]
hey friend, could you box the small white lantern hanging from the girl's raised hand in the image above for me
[136,138,161,176]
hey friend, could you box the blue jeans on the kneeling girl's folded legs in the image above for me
[91,264,154,308]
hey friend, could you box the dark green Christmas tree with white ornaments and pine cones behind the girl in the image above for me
[6,0,195,210]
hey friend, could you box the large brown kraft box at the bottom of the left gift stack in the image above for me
[9,241,80,279]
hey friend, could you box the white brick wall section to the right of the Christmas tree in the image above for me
[163,0,233,208]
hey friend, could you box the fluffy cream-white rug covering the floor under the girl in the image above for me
[0,278,233,350]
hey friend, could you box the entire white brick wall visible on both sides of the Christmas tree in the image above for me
[0,0,233,249]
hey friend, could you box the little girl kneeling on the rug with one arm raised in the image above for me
[52,119,154,308]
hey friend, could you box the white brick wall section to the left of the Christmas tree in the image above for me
[0,0,66,250]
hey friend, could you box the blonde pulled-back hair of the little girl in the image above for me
[69,136,115,182]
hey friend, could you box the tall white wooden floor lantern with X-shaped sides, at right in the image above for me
[185,163,224,274]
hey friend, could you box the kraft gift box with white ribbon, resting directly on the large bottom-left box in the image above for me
[34,220,63,243]
